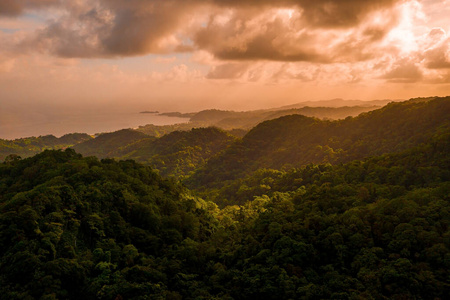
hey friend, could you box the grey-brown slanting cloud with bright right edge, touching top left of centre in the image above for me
[101,0,200,56]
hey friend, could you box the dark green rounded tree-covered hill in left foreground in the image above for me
[0,149,214,299]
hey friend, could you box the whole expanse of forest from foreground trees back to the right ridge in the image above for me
[0,97,450,300]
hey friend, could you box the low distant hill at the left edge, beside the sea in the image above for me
[0,133,92,161]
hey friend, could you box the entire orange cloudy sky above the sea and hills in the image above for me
[0,0,450,115]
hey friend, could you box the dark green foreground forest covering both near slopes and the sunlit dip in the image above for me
[0,135,450,299]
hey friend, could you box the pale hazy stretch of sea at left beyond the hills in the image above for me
[0,112,189,140]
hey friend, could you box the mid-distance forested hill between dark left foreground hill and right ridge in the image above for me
[72,127,236,178]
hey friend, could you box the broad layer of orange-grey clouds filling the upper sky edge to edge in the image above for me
[0,0,450,102]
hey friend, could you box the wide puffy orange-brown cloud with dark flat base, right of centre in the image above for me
[193,2,399,63]
